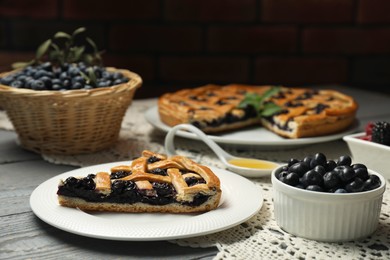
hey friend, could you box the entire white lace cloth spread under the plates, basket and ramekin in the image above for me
[0,99,390,259]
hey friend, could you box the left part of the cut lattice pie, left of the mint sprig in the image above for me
[158,84,269,133]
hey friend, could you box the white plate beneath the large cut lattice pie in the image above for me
[145,106,359,148]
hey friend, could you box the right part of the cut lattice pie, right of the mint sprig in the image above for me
[261,88,358,138]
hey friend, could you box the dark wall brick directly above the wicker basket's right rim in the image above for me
[103,53,157,81]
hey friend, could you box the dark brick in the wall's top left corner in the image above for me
[0,0,58,19]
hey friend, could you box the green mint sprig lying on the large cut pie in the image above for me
[238,87,282,116]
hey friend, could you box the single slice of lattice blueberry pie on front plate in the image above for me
[57,151,222,213]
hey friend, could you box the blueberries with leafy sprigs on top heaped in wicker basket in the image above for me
[0,27,129,90]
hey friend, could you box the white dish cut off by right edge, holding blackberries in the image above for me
[343,132,390,179]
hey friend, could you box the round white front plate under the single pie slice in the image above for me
[30,161,263,241]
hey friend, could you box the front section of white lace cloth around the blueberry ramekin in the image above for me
[171,179,390,260]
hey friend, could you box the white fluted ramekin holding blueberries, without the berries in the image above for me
[271,167,386,242]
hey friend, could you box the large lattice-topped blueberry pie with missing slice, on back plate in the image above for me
[158,84,358,138]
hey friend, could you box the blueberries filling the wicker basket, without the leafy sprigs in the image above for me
[0,62,129,90]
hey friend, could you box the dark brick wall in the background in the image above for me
[0,0,390,98]
